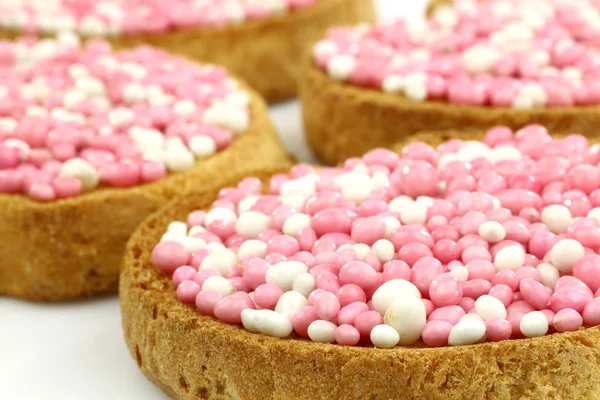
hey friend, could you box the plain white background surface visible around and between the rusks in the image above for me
[0,0,425,400]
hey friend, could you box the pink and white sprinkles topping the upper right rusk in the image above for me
[313,0,600,109]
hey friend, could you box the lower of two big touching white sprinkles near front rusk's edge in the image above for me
[384,296,427,346]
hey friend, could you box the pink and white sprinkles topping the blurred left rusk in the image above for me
[0,34,250,201]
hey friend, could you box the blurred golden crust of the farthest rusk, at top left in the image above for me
[0,0,375,102]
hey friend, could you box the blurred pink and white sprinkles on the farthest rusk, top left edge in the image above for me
[0,0,317,36]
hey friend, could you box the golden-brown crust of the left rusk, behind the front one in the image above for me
[0,85,289,301]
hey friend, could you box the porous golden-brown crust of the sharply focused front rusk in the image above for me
[120,181,600,400]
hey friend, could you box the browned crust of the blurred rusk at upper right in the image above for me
[300,57,600,165]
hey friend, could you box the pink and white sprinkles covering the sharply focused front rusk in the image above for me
[152,125,600,348]
